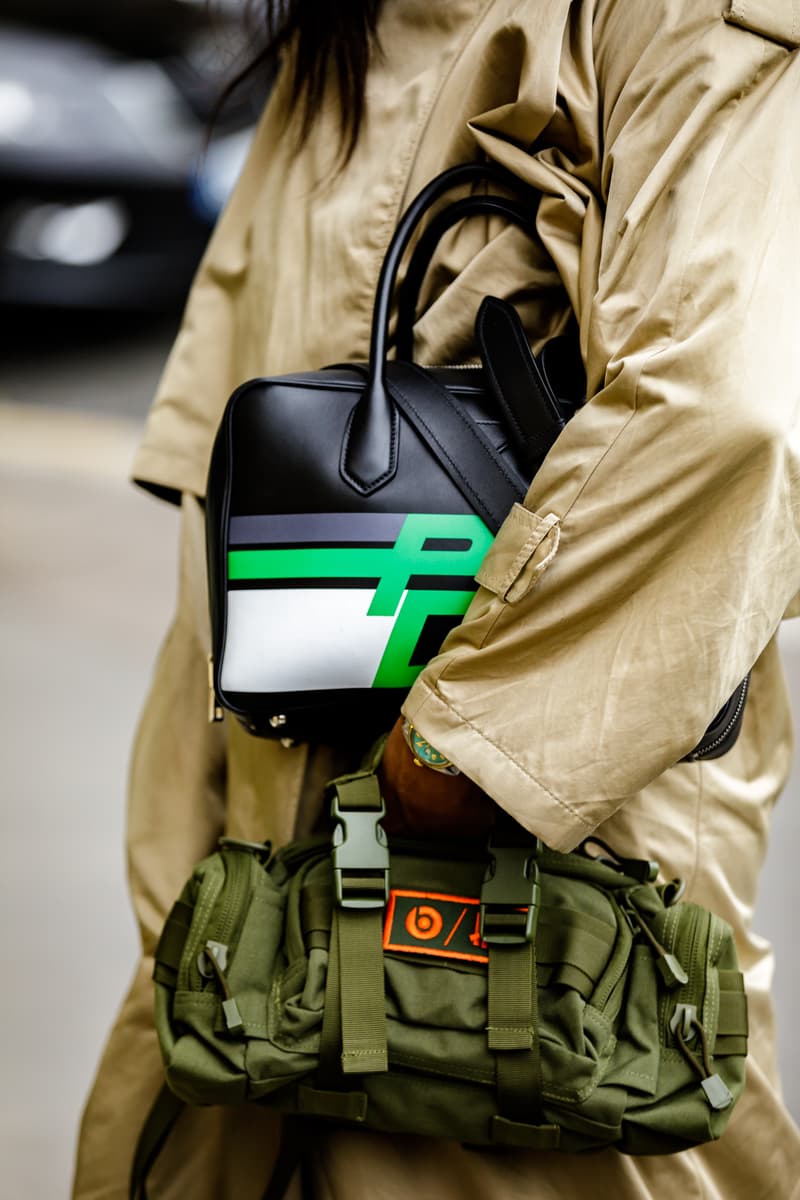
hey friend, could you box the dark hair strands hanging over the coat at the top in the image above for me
[229,0,383,163]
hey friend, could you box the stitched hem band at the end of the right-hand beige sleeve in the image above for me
[403,679,596,852]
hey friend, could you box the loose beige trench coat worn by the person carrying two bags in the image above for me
[74,0,800,1200]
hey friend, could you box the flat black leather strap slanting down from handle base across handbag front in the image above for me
[386,362,527,533]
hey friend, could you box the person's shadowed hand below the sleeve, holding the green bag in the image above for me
[378,719,495,839]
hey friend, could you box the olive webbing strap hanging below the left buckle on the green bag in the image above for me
[333,908,389,1075]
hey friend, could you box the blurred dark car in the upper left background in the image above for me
[0,0,267,311]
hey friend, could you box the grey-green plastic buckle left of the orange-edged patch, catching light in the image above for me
[331,792,389,908]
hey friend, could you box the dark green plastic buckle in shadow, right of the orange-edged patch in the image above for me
[481,834,541,946]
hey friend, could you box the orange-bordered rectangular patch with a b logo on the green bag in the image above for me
[384,888,489,962]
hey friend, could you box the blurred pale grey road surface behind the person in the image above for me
[0,318,800,1200]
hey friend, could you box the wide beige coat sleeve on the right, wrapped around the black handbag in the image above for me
[404,0,800,850]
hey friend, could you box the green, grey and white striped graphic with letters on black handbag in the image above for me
[222,512,492,691]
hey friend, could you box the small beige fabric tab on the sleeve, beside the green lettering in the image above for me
[475,504,560,604]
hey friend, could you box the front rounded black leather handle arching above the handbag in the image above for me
[342,162,539,494]
